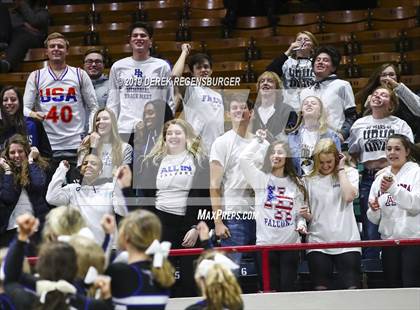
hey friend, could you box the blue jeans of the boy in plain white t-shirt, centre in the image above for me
[221,219,256,265]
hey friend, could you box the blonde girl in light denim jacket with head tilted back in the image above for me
[287,96,341,176]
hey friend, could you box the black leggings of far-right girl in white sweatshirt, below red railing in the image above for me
[382,246,420,287]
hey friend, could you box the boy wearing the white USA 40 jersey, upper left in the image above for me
[23,32,98,179]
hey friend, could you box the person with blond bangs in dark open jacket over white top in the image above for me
[252,71,297,142]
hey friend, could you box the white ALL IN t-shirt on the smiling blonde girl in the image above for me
[156,151,196,215]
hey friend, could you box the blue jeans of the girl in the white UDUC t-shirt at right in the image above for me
[359,170,381,259]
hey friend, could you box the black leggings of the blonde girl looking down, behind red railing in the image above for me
[308,251,361,289]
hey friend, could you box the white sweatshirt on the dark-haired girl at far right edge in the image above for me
[367,162,420,239]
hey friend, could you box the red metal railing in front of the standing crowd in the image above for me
[170,238,420,292]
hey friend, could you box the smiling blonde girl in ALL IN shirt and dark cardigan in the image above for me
[138,119,210,296]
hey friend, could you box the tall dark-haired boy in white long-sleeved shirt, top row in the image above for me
[106,22,174,141]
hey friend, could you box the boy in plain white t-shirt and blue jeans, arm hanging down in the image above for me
[210,96,256,263]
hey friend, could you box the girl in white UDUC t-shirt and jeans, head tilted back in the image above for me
[349,86,413,258]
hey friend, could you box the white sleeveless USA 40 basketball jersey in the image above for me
[34,66,88,151]
